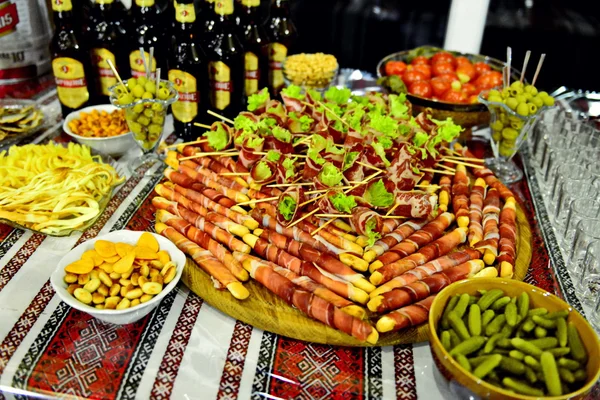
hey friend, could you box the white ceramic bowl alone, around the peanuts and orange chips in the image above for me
[50,230,185,325]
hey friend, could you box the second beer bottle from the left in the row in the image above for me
[91,0,129,103]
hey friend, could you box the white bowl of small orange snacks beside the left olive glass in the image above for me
[63,104,137,157]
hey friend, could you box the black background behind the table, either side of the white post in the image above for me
[284,0,600,91]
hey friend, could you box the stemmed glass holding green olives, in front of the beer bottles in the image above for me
[109,80,179,175]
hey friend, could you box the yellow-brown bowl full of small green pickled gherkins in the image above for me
[429,278,600,399]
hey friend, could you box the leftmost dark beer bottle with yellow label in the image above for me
[50,0,90,117]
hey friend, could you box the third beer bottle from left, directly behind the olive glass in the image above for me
[129,0,167,78]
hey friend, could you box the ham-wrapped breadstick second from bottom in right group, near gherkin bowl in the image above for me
[367,260,484,313]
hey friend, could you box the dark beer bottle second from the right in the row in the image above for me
[239,0,269,96]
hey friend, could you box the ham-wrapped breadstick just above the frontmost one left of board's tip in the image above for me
[233,251,367,319]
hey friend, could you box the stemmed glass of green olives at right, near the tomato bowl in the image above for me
[478,88,549,184]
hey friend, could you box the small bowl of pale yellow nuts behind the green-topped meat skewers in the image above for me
[283,53,339,91]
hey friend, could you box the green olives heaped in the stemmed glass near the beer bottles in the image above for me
[109,76,178,153]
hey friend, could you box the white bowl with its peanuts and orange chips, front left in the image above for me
[50,230,186,325]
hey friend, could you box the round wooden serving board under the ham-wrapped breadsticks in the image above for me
[181,204,532,347]
